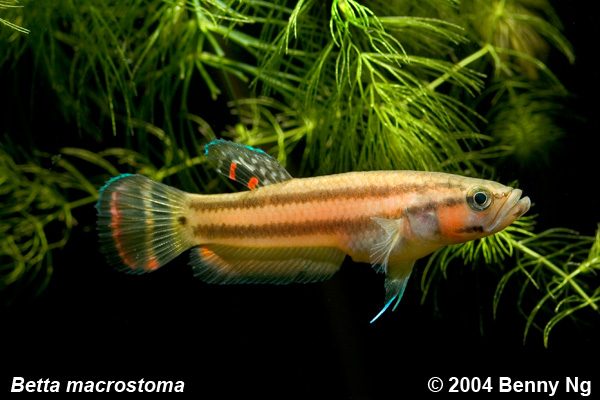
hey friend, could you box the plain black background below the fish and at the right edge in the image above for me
[0,2,600,398]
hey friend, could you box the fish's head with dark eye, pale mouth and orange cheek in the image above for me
[438,179,531,243]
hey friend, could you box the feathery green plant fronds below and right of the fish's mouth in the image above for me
[421,217,600,346]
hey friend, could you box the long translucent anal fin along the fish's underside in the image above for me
[190,244,346,284]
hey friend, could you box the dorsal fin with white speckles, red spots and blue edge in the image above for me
[204,140,292,189]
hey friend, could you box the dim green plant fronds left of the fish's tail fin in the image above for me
[0,145,98,299]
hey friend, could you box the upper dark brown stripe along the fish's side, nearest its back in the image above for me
[190,183,463,212]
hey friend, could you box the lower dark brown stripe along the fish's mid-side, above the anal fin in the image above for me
[194,217,375,239]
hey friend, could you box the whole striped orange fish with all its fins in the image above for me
[96,139,531,322]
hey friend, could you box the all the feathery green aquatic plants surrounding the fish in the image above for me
[0,0,598,344]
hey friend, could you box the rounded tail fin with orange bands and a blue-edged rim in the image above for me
[96,174,192,274]
